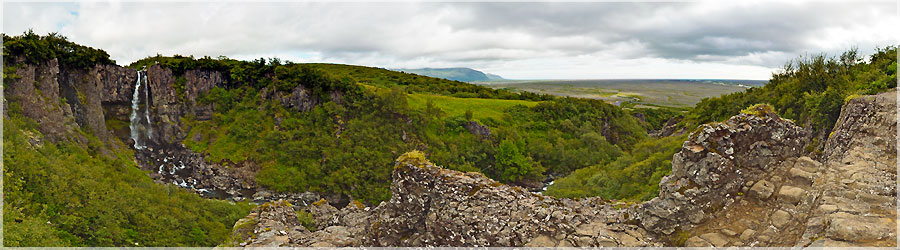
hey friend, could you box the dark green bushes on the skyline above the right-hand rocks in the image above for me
[687,46,897,135]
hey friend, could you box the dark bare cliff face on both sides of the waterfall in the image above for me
[7,58,224,144]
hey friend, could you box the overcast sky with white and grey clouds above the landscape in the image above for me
[3,1,900,80]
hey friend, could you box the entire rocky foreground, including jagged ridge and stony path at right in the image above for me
[229,92,897,247]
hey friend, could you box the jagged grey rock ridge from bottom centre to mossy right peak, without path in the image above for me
[229,105,806,247]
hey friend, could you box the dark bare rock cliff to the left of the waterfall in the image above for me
[6,58,136,145]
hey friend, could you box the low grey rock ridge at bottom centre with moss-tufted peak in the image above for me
[227,151,658,247]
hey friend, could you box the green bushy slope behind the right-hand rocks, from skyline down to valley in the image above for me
[547,47,897,203]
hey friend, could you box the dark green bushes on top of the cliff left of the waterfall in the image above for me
[2,30,115,69]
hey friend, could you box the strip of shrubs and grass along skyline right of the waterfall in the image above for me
[129,55,555,100]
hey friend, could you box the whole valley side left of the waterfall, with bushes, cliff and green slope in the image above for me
[3,32,251,246]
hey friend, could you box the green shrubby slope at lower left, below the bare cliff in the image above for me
[3,113,250,246]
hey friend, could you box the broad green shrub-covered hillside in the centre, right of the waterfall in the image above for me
[126,52,646,203]
